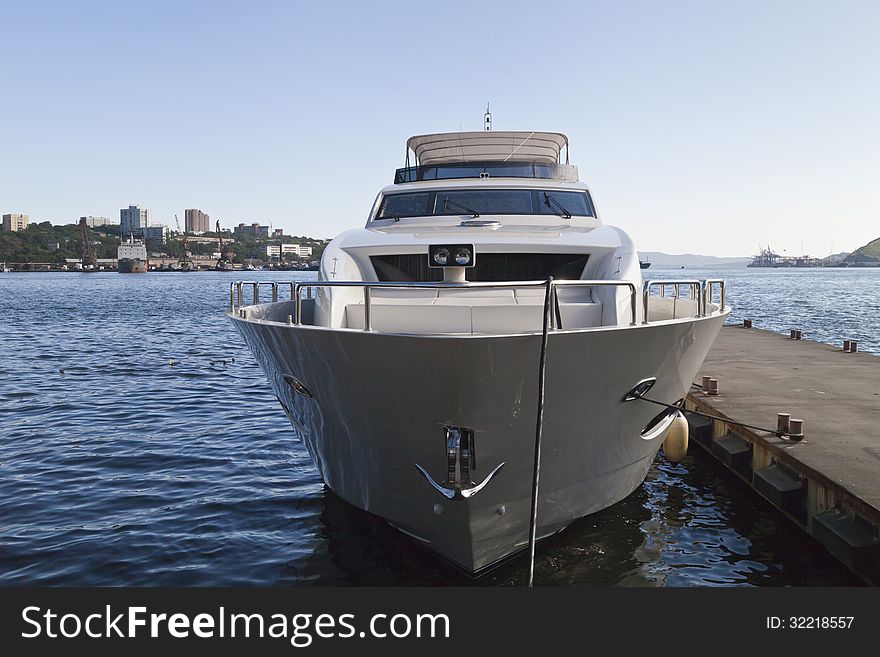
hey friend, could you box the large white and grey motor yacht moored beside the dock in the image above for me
[228,131,729,572]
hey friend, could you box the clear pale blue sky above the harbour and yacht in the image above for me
[0,0,880,255]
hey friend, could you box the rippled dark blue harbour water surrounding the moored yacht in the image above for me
[0,270,868,586]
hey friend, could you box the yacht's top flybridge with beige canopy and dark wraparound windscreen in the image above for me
[394,131,578,184]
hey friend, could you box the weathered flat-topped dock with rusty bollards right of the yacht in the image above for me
[687,326,880,585]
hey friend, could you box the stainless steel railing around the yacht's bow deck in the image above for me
[229,279,724,331]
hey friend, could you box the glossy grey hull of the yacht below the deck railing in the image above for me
[229,304,727,572]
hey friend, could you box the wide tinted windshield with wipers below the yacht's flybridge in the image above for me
[376,189,595,219]
